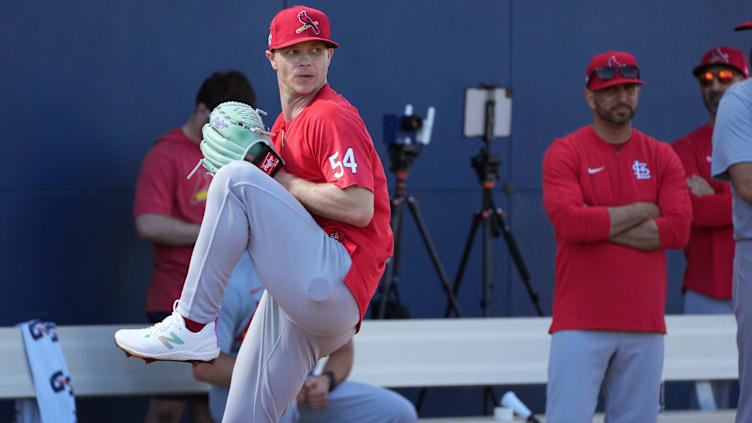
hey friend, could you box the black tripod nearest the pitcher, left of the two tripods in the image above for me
[376,144,462,319]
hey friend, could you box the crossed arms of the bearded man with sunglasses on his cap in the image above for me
[543,142,692,251]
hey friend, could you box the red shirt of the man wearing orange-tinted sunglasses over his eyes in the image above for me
[672,124,736,299]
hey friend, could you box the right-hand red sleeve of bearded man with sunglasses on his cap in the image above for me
[655,145,692,249]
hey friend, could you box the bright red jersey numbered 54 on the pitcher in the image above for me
[271,84,394,319]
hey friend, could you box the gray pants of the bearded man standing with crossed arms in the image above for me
[546,330,663,423]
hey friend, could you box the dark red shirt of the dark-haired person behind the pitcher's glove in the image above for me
[133,128,211,312]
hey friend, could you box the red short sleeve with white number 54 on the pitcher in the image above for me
[310,112,376,191]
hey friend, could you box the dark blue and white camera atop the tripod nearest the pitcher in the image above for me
[384,104,436,173]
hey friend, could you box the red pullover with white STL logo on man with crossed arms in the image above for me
[543,126,692,333]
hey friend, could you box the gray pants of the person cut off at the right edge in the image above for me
[731,241,752,423]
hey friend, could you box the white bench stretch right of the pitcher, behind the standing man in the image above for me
[350,315,738,388]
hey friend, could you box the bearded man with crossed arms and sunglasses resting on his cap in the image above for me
[543,51,692,423]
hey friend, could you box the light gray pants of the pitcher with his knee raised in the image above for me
[178,161,360,423]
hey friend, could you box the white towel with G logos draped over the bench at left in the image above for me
[16,320,77,423]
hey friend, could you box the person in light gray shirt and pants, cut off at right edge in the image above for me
[711,16,752,423]
